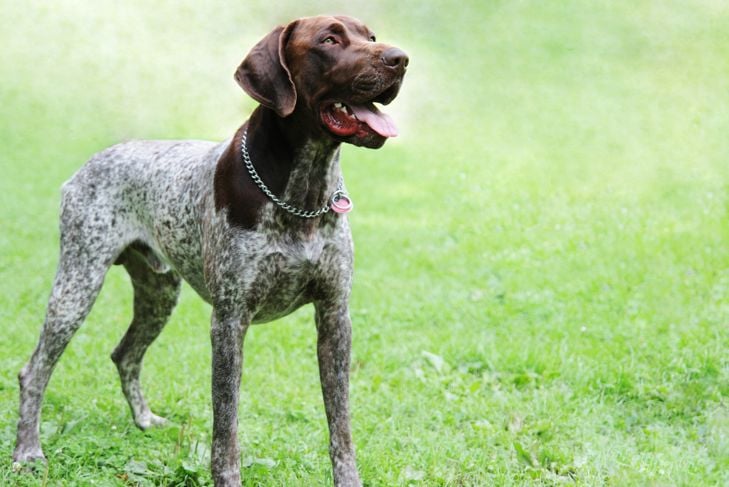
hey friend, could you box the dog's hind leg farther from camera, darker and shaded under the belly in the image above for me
[111,246,180,429]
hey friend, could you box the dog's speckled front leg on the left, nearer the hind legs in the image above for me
[210,310,248,487]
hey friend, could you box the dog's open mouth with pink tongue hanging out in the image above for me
[321,102,397,138]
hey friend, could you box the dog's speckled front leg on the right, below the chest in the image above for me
[316,298,361,487]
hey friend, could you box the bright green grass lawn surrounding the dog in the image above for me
[0,0,729,486]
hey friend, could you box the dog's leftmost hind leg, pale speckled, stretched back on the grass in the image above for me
[13,233,115,462]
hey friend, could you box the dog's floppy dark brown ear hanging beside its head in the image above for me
[235,21,297,117]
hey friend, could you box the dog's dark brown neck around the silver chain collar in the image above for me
[215,106,340,233]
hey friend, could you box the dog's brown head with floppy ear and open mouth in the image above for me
[235,16,408,148]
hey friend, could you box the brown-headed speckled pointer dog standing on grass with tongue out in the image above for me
[13,17,408,486]
